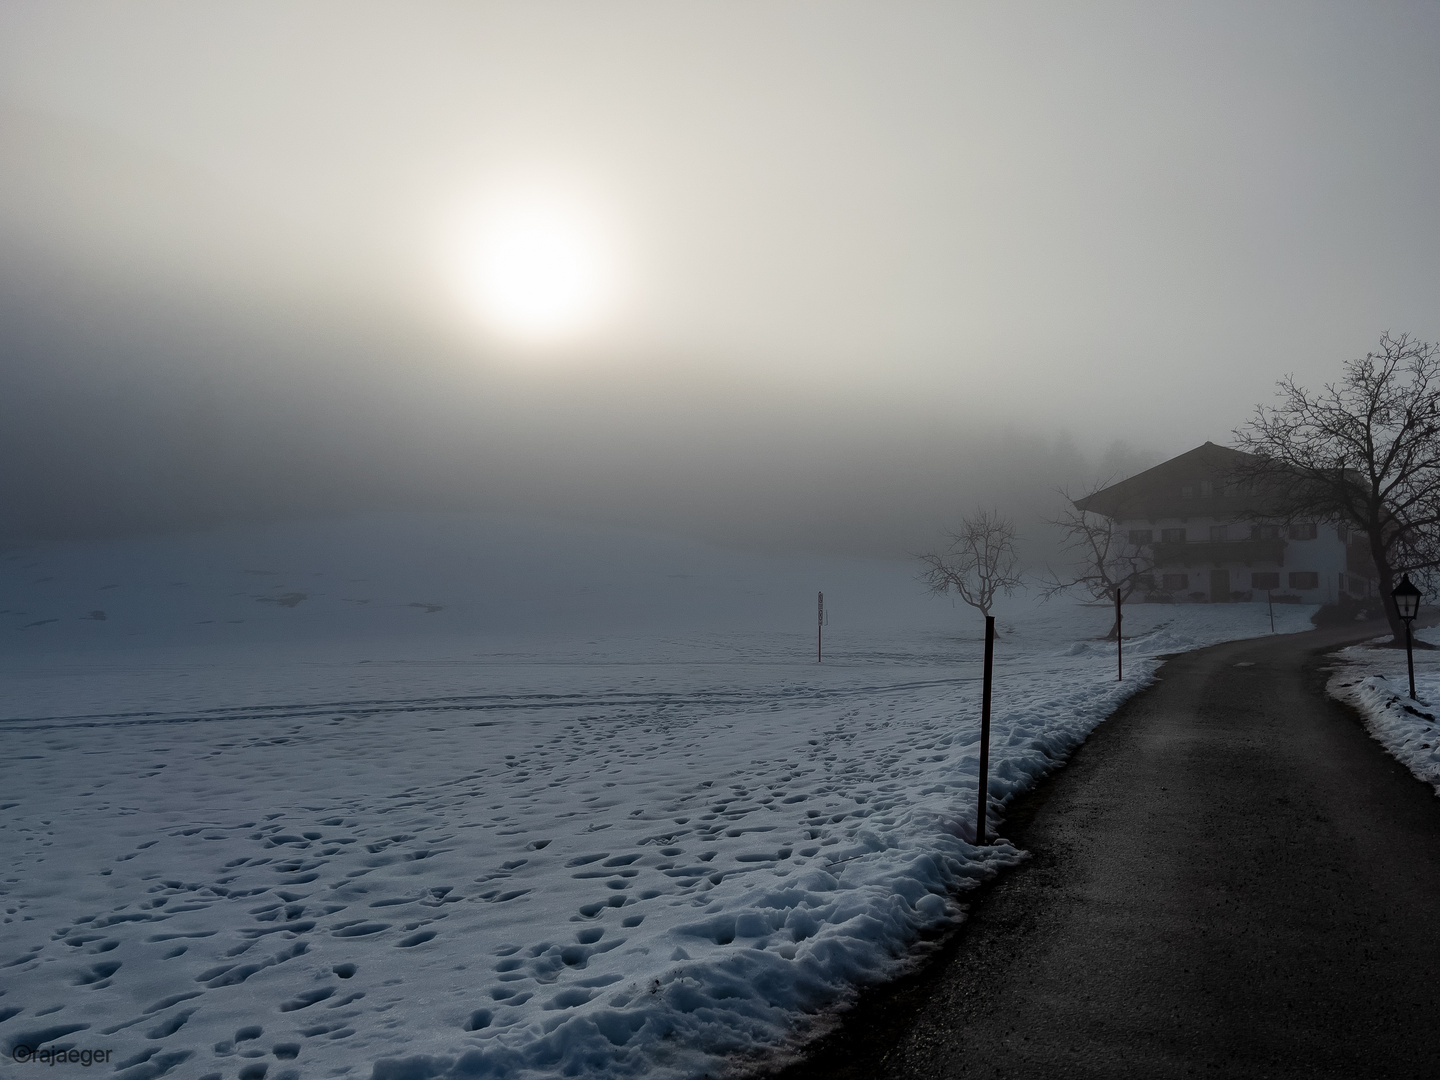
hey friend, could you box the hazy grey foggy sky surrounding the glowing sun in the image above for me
[0,0,1440,552]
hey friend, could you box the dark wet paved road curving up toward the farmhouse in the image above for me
[780,628,1440,1080]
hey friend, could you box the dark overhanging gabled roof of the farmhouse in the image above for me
[1076,442,1263,521]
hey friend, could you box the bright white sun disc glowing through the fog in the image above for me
[452,192,619,343]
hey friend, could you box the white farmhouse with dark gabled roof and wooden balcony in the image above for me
[1076,442,1377,603]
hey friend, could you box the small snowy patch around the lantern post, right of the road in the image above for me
[1326,626,1440,795]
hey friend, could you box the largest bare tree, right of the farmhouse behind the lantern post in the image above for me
[1236,333,1440,642]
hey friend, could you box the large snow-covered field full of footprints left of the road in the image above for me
[0,516,1313,1080]
